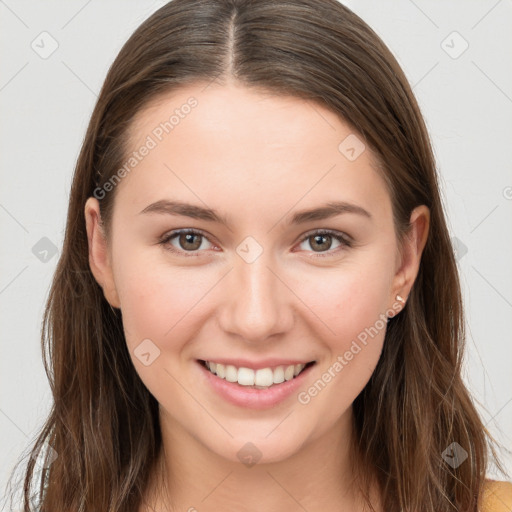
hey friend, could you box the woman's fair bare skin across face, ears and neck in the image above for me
[85,83,429,512]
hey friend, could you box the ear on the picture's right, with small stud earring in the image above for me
[390,205,430,310]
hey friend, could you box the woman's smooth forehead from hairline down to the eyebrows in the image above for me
[118,84,391,227]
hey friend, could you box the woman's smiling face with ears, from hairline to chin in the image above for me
[86,84,428,462]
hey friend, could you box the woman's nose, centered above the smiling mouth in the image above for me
[218,251,294,344]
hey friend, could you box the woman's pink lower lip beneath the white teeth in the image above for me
[196,361,316,409]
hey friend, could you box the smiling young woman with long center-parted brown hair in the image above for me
[6,0,512,512]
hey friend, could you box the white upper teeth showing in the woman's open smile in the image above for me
[198,359,316,389]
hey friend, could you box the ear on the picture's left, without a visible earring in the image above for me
[84,197,121,308]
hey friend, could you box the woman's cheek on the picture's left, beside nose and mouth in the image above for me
[114,254,219,404]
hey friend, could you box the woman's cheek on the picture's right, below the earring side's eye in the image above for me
[298,265,390,418]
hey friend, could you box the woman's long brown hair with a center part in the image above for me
[5,0,503,512]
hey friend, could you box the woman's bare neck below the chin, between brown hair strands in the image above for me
[141,408,379,512]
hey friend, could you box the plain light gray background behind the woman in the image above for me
[0,0,512,504]
